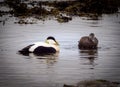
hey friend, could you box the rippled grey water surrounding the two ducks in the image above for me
[0,14,120,87]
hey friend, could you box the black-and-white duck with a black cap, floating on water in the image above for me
[19,36,59,55]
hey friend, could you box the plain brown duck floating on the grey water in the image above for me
[78,33,98,49]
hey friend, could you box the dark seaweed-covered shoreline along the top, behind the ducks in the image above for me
[0,0,120,24]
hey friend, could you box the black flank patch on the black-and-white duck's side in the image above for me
[33,46,56,55]
